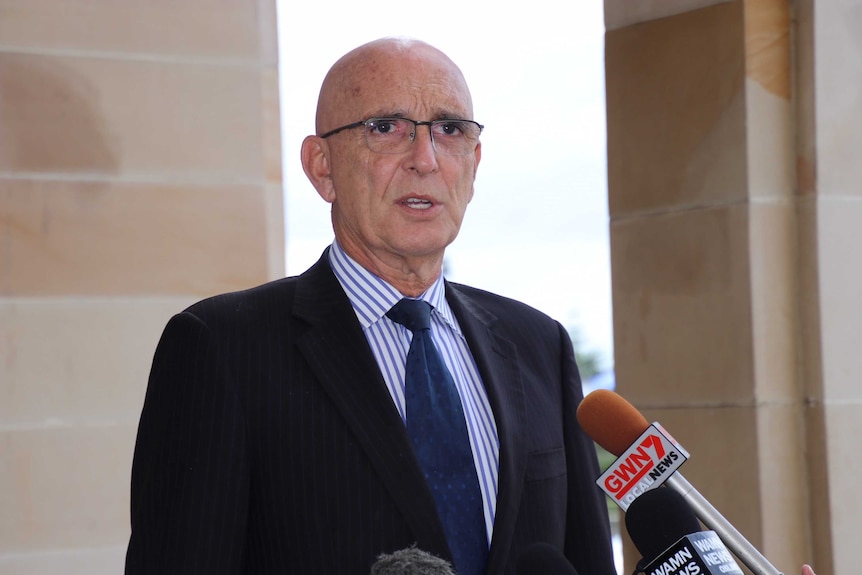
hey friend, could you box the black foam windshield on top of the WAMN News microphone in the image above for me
[626,487,700,563]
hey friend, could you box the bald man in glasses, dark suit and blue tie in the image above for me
[126,39,615,575]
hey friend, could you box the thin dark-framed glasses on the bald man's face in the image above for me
[320,118,485,156]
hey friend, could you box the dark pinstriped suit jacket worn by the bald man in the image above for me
[126,254,614,575]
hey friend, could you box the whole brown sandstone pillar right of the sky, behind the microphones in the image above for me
[605,0,862,575]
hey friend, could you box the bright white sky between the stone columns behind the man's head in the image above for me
[278,0,613,367]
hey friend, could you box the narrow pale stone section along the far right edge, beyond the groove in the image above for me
[794,0,862,575]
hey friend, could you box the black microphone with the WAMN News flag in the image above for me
[626,487,742,575]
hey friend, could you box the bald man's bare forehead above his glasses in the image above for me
[334,45,473,123]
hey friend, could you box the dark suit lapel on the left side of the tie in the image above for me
[293,252,448,556]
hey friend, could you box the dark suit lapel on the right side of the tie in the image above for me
[446,282,527,573]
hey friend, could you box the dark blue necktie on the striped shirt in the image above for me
[386,298,488,575]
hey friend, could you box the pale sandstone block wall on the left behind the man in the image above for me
[0,0,284,575]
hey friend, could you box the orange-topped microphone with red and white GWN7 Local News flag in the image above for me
[577,389,783,575]
